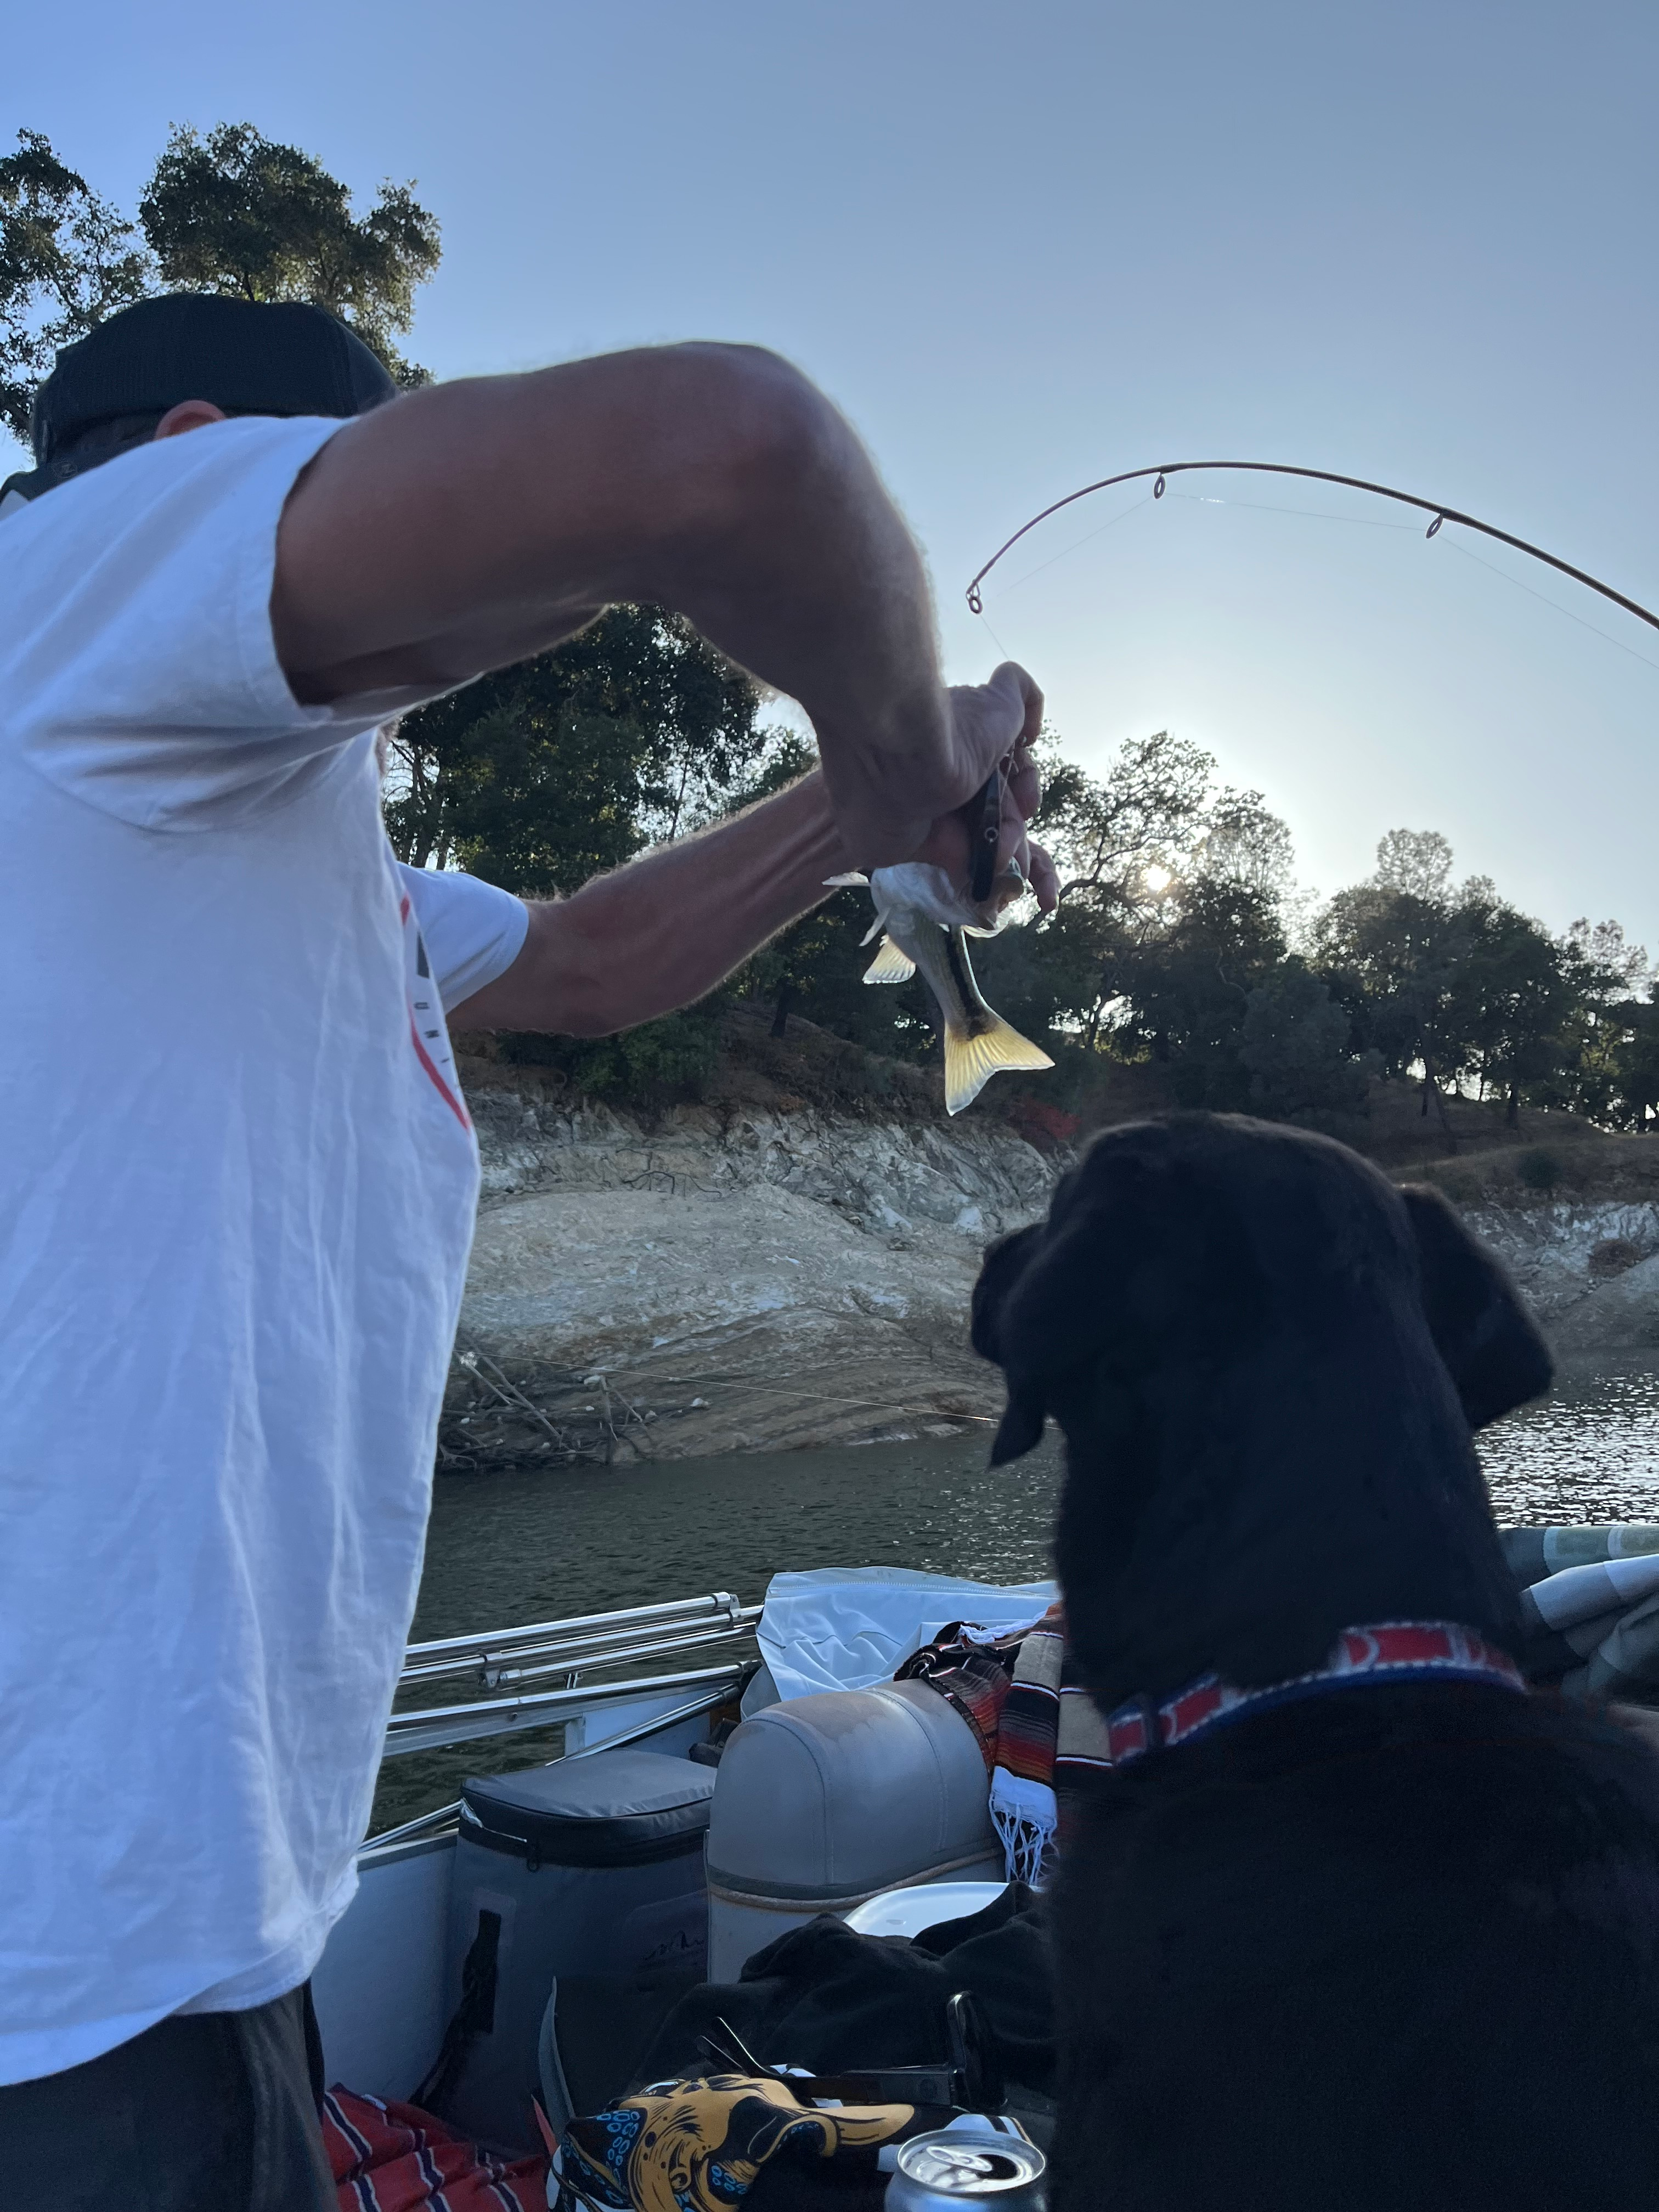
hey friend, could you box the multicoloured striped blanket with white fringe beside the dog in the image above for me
[896,1606,1110,1889]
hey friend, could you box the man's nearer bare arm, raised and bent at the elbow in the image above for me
[272,345,1042,865]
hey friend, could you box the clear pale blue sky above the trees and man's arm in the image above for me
[13,0,1659,953]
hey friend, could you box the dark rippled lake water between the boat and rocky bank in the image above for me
[374,1361,1659,1829]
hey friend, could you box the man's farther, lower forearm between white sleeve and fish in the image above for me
[452,774,849,1037]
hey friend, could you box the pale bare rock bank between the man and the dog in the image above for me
[454,1091,1066,1458]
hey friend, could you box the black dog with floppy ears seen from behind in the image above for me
[973,1117,1659,2212]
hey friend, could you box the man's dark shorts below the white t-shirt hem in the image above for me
[0,1989,338,2212]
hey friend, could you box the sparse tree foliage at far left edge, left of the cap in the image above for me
[0,131,155,444]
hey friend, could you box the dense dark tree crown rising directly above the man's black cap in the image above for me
[139,124,442,385]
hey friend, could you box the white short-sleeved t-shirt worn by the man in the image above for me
[0,420,527,2084]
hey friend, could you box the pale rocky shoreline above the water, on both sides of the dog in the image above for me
[440,1086,1659,1469]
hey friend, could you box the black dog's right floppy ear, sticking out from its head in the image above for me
[1400,1183,1555,1429]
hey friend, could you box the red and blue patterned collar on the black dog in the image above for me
[1106,1621,1526,1768]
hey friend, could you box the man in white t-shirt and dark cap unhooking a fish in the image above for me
[0,296,1051,2212]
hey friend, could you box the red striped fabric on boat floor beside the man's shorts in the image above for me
[323,2088,546,2212]
